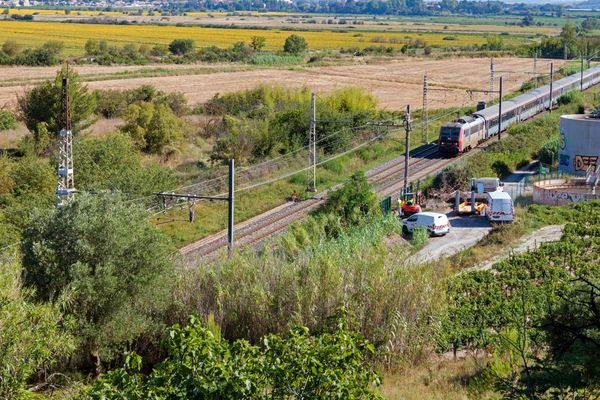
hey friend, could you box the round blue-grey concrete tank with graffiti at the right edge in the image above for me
[558,114,600,175]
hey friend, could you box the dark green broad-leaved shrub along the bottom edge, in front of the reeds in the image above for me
[88,318,381,400]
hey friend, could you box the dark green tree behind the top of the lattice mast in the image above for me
[18,67,95,138]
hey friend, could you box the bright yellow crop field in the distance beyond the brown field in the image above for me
[0,21,535,55]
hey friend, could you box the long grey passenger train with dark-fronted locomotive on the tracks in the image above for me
[438,66,600,155]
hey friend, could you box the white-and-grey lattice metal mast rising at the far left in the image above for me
[56,64,75,208]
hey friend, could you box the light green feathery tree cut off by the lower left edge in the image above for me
[0,256,74,399]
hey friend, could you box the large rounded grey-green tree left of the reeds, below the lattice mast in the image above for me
[21,193,174,373]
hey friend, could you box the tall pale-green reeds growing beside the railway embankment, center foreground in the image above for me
[175,217,446,363]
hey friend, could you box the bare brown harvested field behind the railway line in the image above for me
[0,57,561,110]
